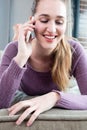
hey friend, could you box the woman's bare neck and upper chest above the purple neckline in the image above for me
[29,39,52,72]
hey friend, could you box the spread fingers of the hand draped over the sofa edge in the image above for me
[8,101,40,126]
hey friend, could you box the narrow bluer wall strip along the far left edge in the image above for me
[0,0,10,49]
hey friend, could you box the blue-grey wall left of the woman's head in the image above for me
[0,0,33,49]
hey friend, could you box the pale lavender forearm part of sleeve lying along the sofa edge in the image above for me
[55,91,87,110]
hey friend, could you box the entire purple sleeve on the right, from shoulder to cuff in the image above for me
[54,43,87,110]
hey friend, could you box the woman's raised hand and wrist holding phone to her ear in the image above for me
[14,18,35,67]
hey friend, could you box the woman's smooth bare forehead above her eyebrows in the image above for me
[36,0,66,17]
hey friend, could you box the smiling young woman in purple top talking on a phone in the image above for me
[0,0,87,126]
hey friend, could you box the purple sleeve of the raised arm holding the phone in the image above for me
[0,43,26,108]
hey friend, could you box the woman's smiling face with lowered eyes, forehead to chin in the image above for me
[35,0,66,50]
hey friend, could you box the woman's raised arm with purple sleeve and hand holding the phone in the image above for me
[0,19,35,108]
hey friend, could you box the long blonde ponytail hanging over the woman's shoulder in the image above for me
[52,38,72,90]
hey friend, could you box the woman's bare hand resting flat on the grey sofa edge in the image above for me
[8,92,60,126]
